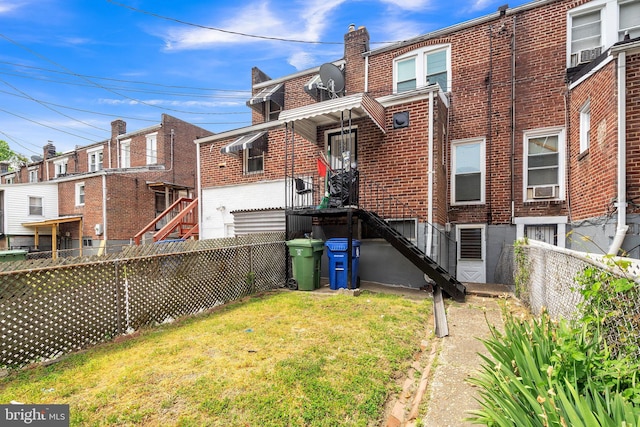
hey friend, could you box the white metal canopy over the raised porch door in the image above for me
[280,93,386,143]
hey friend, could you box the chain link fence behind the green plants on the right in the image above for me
[515,240,640,360]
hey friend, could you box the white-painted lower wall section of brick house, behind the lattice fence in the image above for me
[200,180,285,239]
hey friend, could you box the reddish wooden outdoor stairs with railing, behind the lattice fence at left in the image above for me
[133,197,198,245]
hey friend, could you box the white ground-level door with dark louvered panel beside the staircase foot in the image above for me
[456,224,487,283]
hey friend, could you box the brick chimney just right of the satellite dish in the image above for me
[344,24,369,94]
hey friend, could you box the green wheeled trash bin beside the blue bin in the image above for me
[287,239,324,291]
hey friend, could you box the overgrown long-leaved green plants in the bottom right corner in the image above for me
[470,260,640,427]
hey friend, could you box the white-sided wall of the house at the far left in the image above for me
[0,183,58,235]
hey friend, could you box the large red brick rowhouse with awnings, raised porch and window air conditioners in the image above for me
[197,0,640,286]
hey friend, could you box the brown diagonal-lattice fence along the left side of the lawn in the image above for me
[0,233,286,368]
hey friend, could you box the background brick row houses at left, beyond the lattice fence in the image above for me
[1,114,211,253]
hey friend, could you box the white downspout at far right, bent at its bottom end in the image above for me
[607,52,629,255]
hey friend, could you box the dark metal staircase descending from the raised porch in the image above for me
[358,210,466,302]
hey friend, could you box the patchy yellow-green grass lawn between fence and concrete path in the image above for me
[0,291,431,427]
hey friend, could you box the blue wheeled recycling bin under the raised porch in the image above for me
[325,237,360,290]
